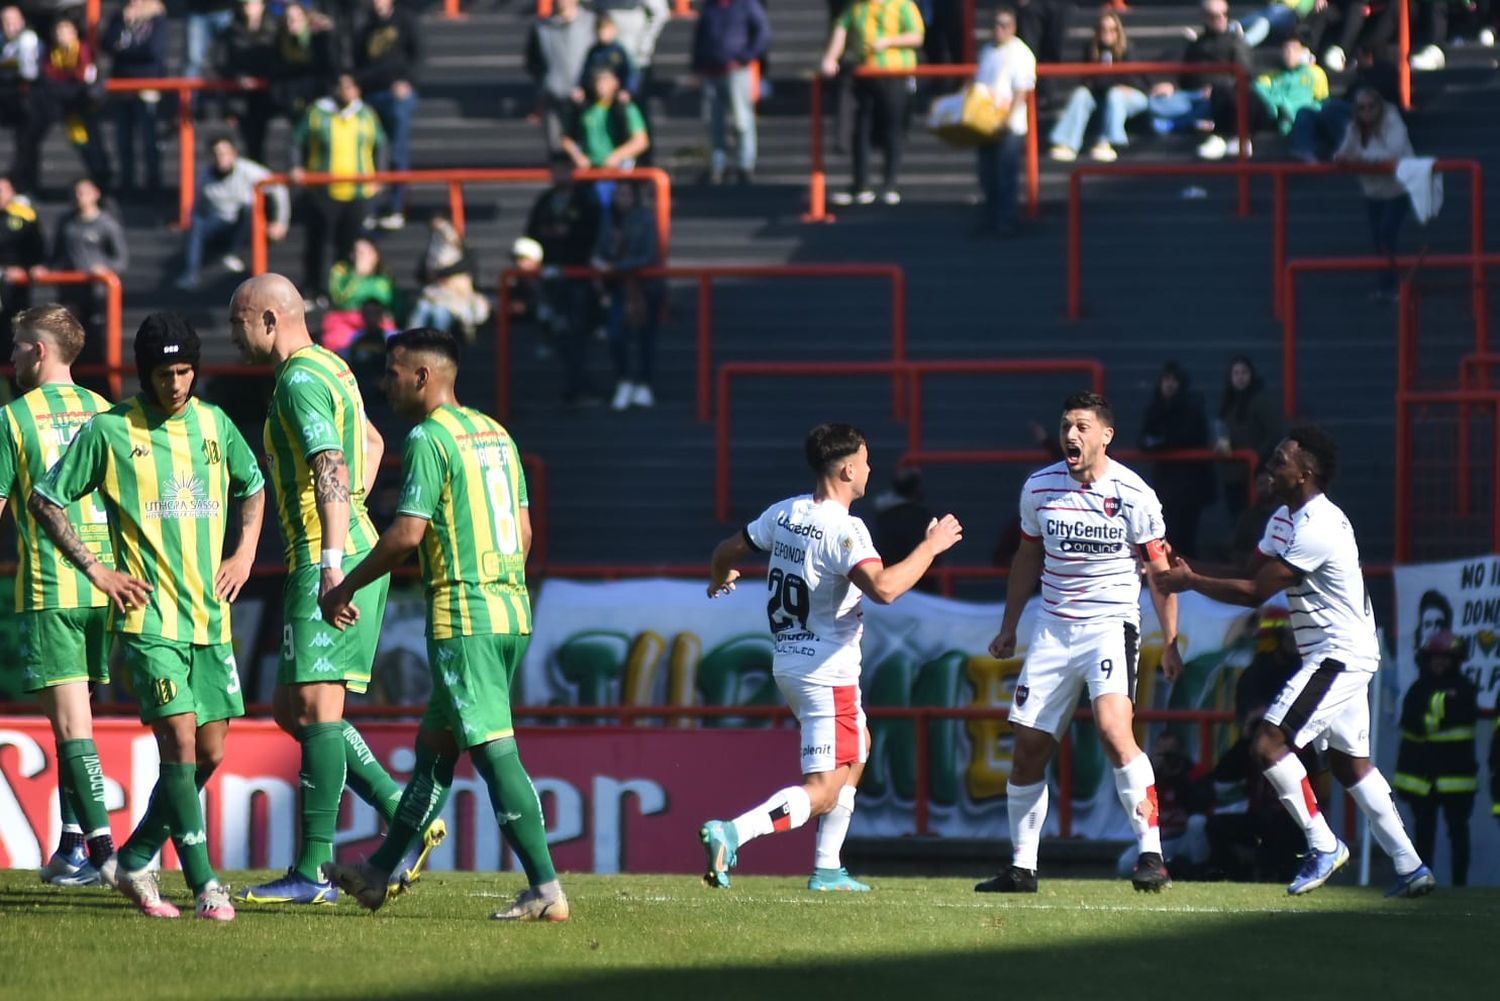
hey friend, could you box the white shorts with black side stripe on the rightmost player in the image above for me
[1266,657,1376,758]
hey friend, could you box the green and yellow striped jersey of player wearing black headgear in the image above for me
[35,396,266,645]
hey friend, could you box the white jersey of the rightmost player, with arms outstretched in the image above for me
[1260,494,1380,671]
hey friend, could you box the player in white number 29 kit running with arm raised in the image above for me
[699,423,963,891]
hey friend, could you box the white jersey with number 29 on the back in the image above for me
[746,494,881,684]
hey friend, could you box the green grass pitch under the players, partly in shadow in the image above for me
[0,872,1500,1001]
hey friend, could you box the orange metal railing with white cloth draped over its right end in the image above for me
[1067,159,1484,320]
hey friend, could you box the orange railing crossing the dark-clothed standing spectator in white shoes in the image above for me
[495,264,906,422]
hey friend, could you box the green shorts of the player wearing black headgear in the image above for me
[120,633,245,726]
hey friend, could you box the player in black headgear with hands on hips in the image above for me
[30,312,266,921]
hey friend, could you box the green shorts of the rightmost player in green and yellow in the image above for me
[422,633,531,747]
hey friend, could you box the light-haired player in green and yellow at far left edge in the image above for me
[0,305,114,887]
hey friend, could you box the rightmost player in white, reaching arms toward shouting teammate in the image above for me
[1157,428,1437,897]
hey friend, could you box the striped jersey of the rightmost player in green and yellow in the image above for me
[398,405,531,639]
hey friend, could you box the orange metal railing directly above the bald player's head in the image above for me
[251,167,672,275]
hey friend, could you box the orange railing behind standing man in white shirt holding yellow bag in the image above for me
[803,61,1250,222]
